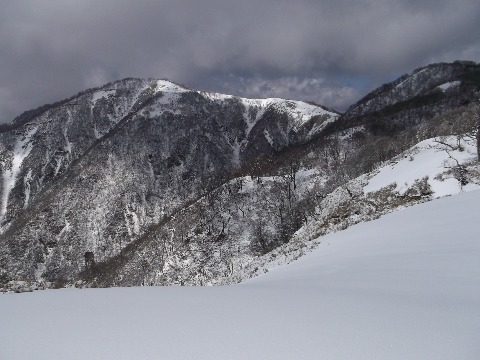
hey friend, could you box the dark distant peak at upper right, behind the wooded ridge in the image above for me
[332,61,480,135]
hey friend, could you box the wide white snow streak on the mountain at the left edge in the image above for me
[0,127,37,223]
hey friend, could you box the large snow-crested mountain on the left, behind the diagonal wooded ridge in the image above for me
[0,79,338,290]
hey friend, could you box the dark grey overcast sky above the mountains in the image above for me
[0,0,480,122]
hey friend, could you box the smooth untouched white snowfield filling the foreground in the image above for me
[0,191,480,360]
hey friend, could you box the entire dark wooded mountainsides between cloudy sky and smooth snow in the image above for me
[0,62,480,290]
